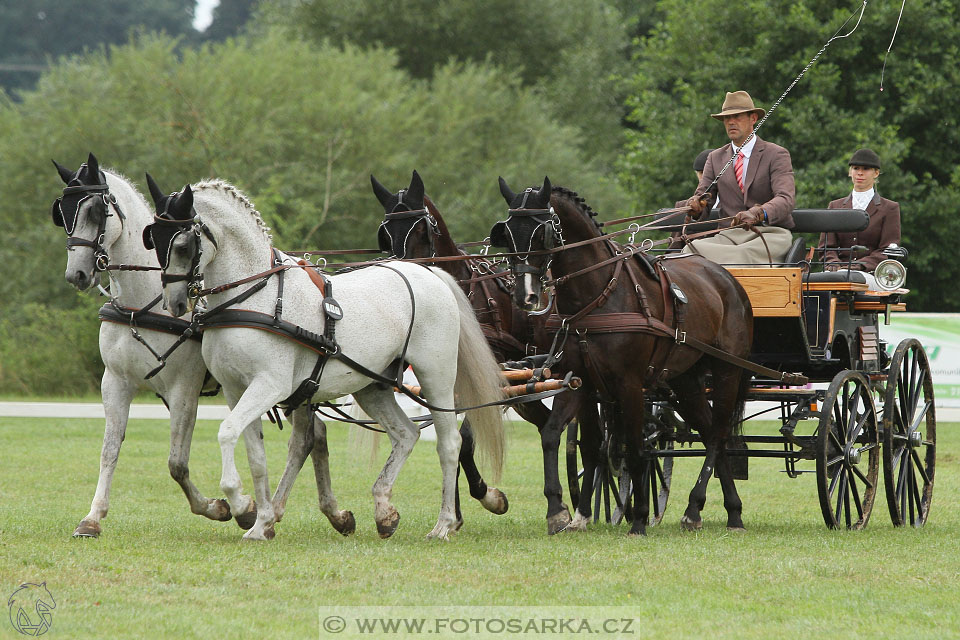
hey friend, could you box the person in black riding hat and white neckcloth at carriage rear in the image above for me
[820,149,900,288]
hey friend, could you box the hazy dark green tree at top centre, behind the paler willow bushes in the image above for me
[262,0,629,163]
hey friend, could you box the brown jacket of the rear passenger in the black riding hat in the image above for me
[820,193,900,271]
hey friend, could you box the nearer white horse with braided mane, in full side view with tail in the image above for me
[145,176,503,539]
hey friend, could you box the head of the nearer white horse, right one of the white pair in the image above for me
[143,173,210,317]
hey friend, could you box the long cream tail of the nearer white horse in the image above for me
[431,268,504,482]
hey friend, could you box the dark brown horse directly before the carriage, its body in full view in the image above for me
[490,178,753,534]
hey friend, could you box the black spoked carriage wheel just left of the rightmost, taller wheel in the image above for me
[816,370,880,529]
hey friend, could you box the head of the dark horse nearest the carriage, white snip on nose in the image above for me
[490,177,561,311]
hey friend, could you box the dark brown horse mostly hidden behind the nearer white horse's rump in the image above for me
[370,171,600,534]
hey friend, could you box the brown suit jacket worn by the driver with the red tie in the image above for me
[694,138,795,229]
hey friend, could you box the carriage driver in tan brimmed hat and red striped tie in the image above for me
[684,91,795,264]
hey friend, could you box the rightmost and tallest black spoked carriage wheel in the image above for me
[883,338,937,527]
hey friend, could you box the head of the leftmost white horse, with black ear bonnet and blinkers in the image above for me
[51,153,122,291]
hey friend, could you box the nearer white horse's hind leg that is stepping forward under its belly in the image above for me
[353,384,420,538]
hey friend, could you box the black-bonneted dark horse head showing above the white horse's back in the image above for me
[370,171,440,259]
